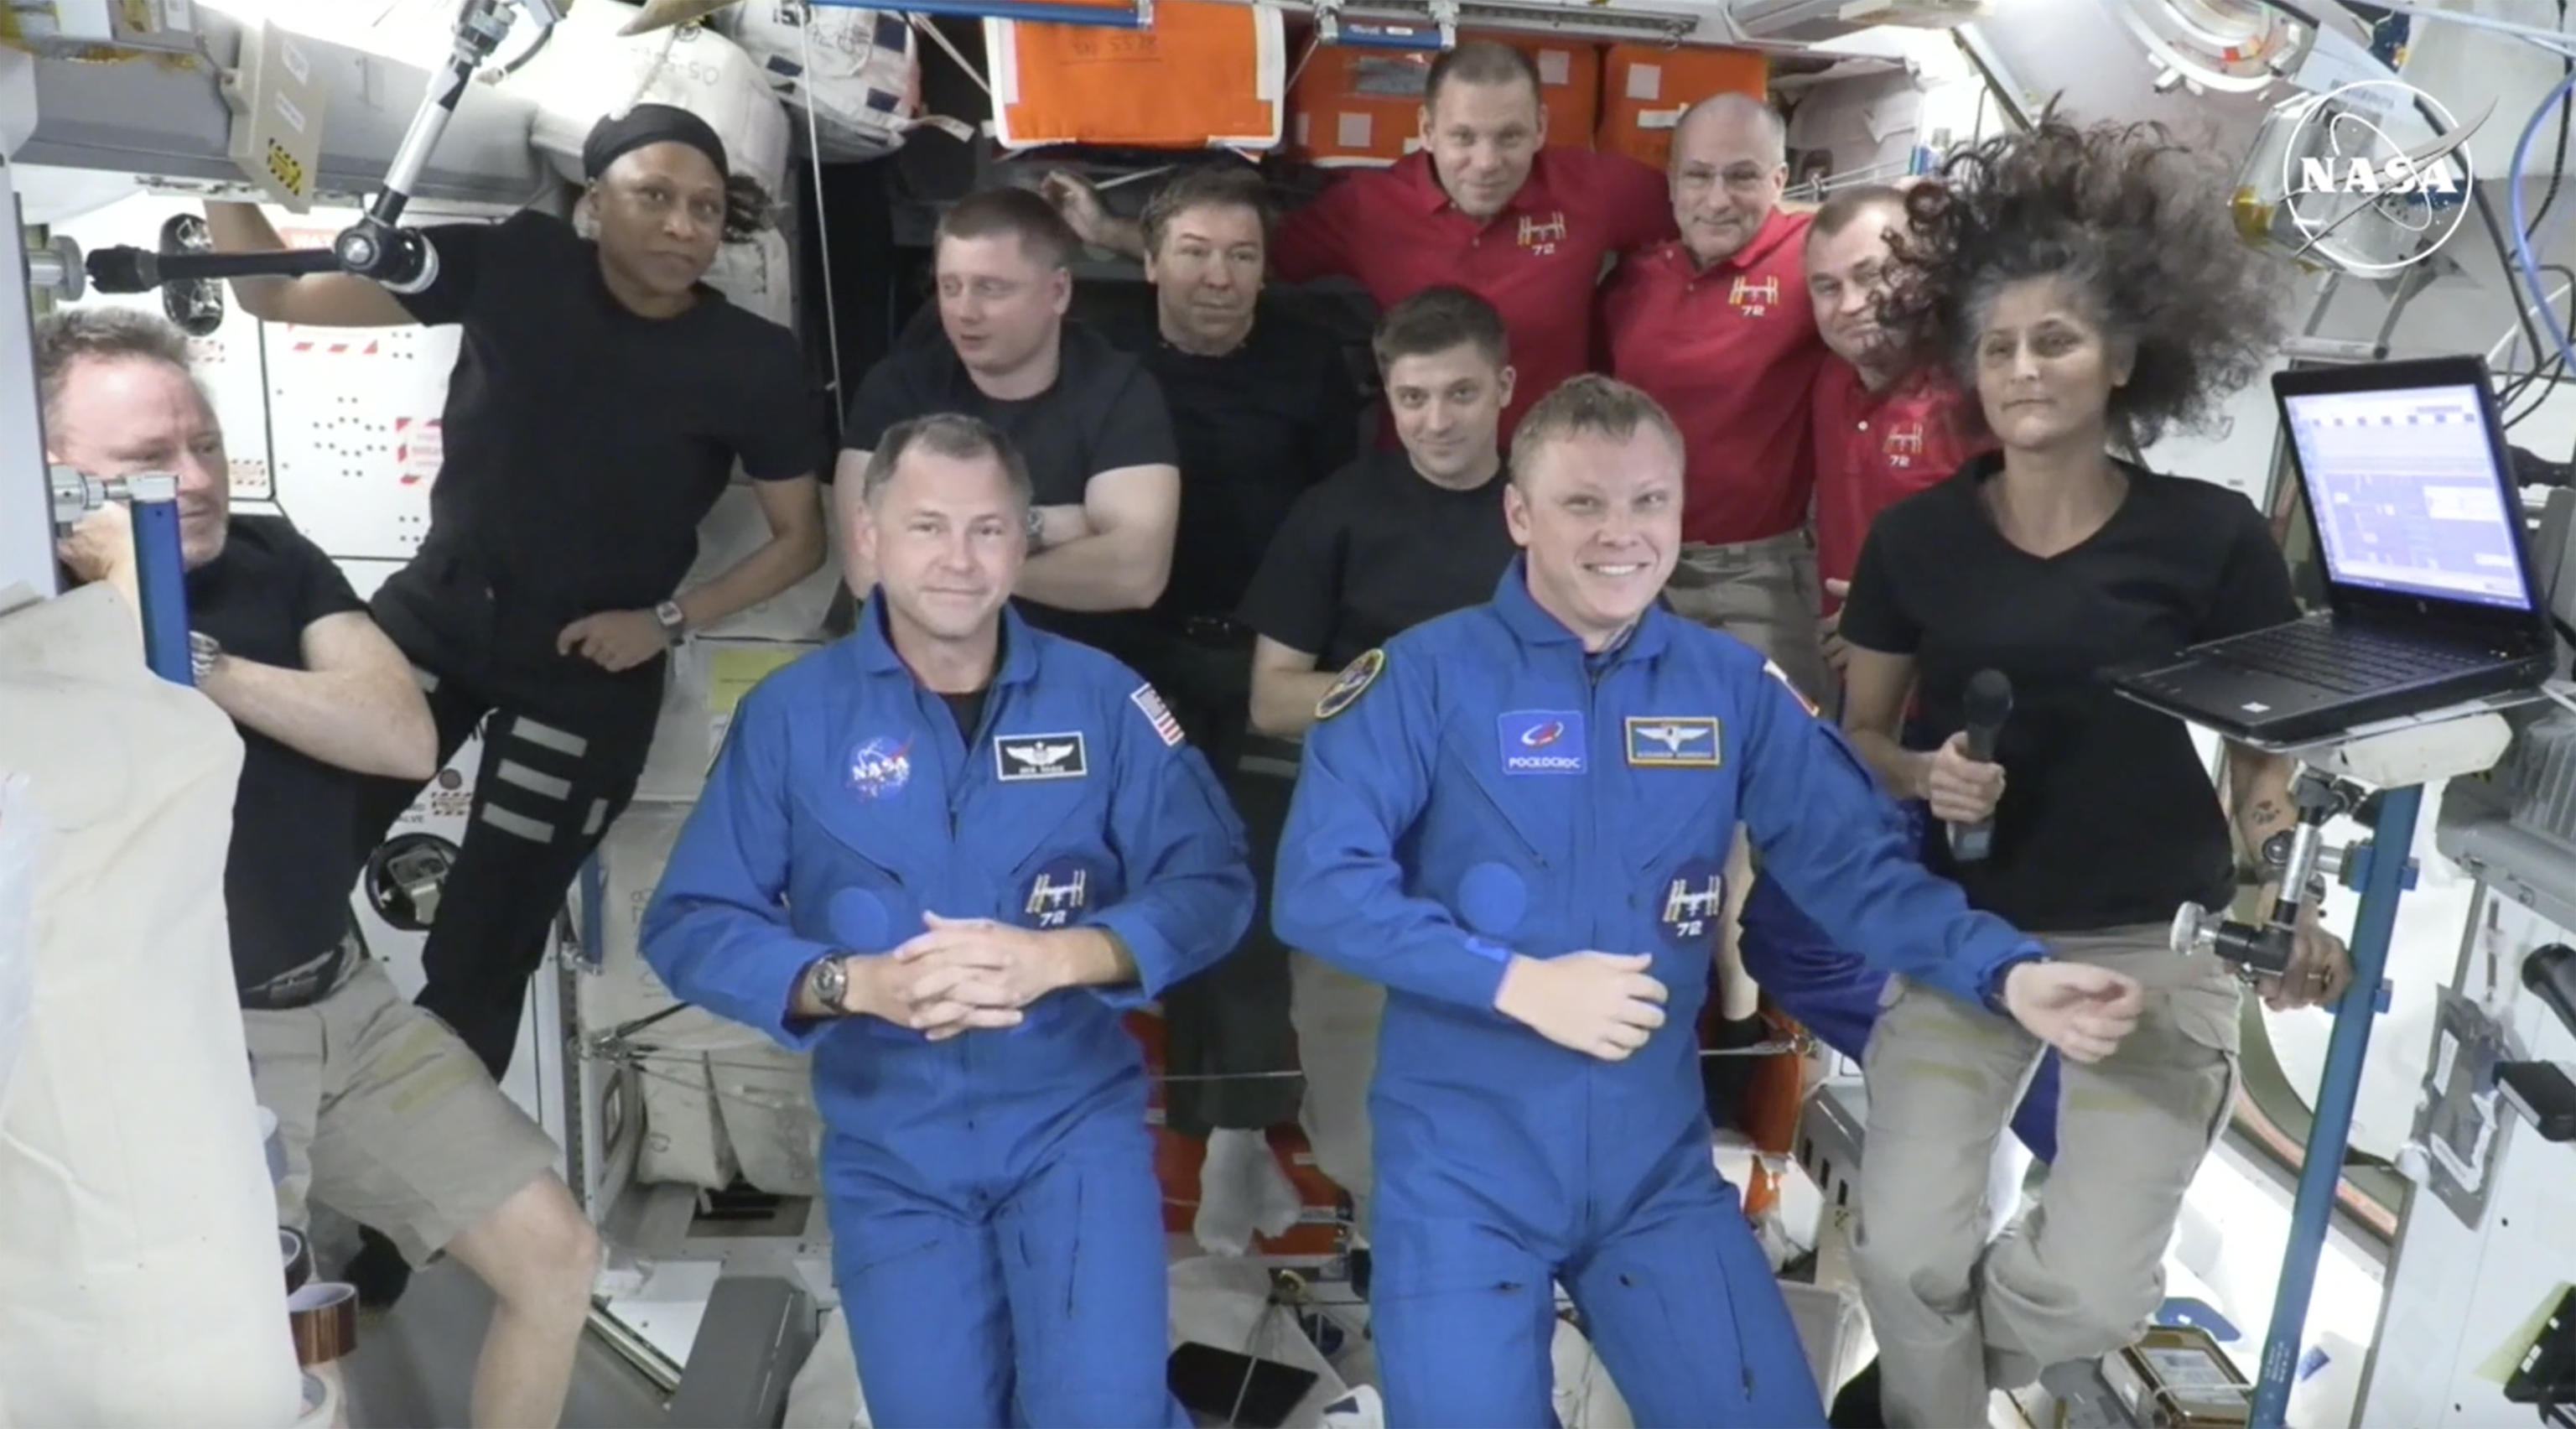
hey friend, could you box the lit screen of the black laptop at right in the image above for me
[2283,383,2532,611]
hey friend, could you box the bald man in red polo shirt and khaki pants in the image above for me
[1602,96,1826,698]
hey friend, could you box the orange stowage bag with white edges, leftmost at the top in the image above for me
[984,0,1288,149]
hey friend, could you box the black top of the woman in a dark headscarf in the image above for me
[397,211,829,631]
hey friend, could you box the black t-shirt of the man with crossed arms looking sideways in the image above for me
[839,322,1180,647]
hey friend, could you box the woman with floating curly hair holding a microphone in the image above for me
[1836,113,2352,1429]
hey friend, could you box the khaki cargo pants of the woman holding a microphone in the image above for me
[1852,924,2239,1429]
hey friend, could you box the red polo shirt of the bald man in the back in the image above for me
[1602,211,1826,546]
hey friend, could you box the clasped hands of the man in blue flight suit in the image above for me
[843,912,1072,1042]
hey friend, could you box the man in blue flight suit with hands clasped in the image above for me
[644,417,1252,1429]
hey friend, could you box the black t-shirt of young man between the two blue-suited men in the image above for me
[1239,450,1517,669]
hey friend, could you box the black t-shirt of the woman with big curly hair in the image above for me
[1841,455,2298,932]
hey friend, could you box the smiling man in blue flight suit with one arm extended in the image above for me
[1273,376,2141,1429]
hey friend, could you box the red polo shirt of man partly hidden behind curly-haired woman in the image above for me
[1816,358,1994,616]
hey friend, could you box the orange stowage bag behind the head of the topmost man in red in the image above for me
[1288,36,1602,168]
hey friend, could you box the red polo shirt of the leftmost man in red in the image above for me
[1270,149,1675,440]
